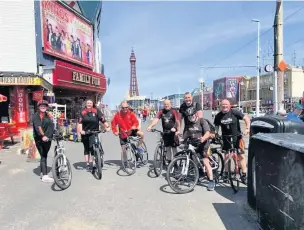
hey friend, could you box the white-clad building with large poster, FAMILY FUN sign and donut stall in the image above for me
[0,0,107,124]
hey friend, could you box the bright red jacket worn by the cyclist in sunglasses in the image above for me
[111,111,139,133]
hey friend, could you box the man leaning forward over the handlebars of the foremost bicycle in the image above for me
[183,113,215,191]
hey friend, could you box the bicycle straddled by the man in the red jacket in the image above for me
[119,130,149,176]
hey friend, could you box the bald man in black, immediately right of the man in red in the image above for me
[147,100,180,165]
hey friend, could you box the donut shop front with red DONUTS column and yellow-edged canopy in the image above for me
[0,74,52,128]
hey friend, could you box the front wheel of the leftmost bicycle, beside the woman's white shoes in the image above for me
[52,154,72,190]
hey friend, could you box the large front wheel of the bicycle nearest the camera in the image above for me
[167,156,199,194]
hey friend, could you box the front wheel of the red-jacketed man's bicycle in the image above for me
[121,145,136,176]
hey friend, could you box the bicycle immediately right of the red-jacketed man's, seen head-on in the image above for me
[151,129,177,177]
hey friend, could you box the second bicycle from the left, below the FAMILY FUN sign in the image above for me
[85,130,106,180]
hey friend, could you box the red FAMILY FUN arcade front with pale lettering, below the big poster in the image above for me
[53,60,106,119]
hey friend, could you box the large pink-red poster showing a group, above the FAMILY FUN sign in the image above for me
[41,0,94,69]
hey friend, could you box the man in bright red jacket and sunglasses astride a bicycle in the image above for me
[111,101,144,153]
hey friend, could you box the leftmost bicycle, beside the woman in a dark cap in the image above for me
[52,132,72,190]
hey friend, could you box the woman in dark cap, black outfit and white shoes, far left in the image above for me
[32,100,54,183]
